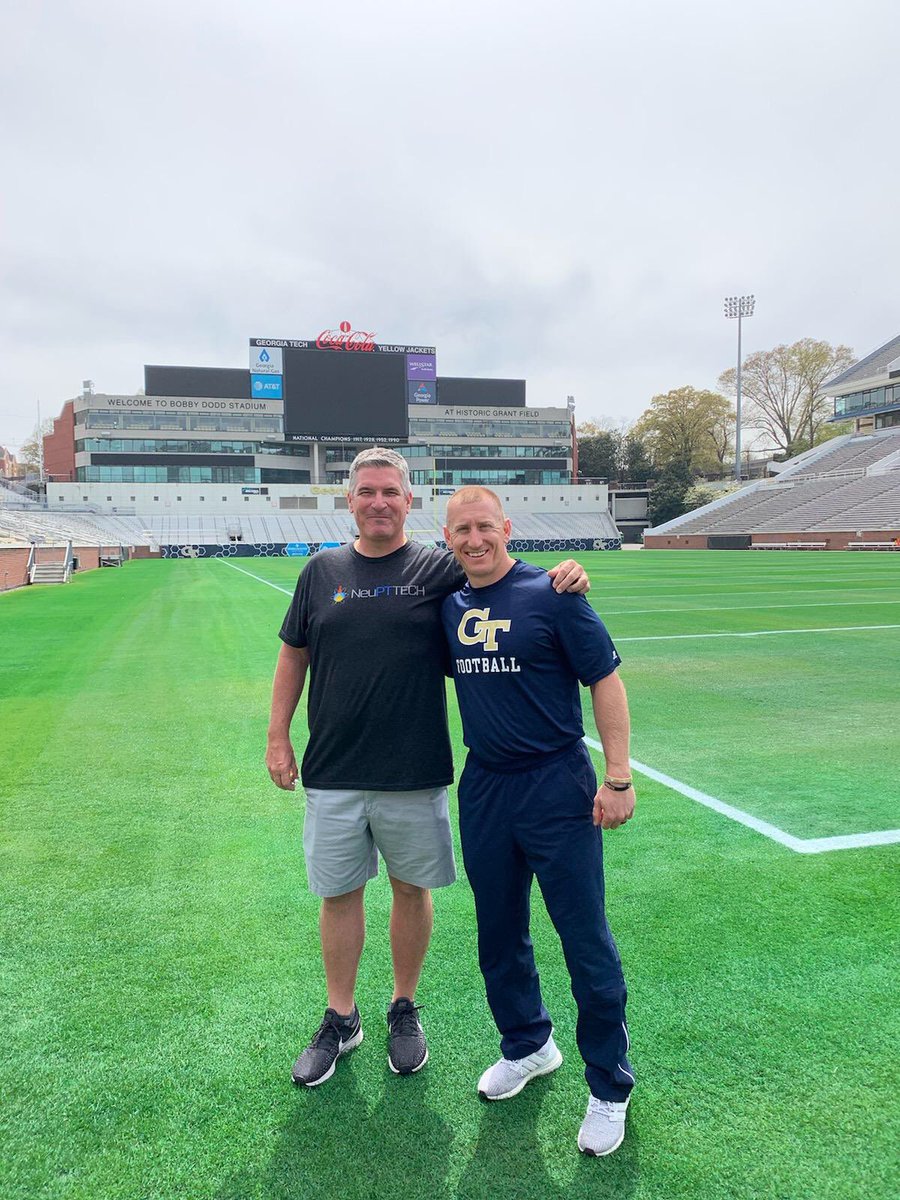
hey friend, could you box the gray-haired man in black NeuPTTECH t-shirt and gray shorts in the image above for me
[266,448,587,1087]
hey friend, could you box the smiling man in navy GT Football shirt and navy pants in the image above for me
[442,487,635,1156]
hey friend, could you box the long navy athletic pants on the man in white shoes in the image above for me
[460,742,635,1100]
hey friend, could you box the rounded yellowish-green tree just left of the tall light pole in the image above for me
[632,386,734,474]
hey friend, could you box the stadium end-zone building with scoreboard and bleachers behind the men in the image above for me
[0,331,628,586]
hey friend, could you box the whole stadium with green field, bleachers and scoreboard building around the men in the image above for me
[0,330,900,1200]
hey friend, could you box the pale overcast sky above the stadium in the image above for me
[0,0,900,448]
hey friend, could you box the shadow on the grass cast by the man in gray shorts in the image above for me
[216,1069,454,1200]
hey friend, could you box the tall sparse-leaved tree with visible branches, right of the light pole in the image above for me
[719,337,854,458]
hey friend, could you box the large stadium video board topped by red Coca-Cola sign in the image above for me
[250,322,437,443]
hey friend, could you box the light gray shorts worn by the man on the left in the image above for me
[304,787,456,896]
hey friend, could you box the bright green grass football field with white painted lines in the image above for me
[0,552,900,1200]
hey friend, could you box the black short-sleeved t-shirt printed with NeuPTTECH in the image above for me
[278,541,466,792]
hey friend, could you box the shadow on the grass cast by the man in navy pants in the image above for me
[456,1084,640,1200]
